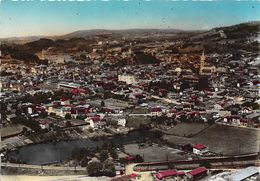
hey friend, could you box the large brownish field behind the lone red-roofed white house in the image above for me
[164,125,260,155]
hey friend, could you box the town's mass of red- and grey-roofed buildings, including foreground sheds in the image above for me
[0,31,260,181]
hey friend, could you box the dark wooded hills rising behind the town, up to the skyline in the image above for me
[0,21,260,64]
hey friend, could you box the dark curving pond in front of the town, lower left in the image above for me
[8,131,158,165]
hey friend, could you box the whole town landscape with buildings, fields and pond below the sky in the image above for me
[0,22,260,181]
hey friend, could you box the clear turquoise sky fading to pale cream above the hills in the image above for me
[0,0,260,38]
